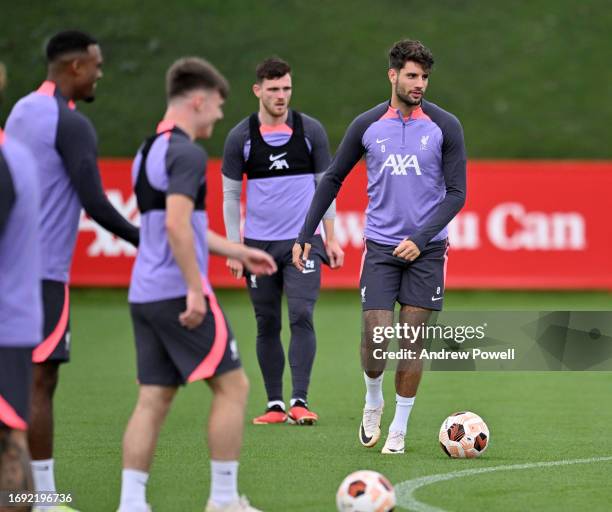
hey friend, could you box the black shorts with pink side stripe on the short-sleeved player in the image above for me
[130,296,241,387]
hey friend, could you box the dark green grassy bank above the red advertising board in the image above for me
[0,0,612,158]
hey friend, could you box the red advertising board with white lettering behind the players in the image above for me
[71,159,612,289]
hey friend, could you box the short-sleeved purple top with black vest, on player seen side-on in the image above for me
[128,121,208,303]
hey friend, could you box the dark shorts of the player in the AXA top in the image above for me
[359,240,448,311]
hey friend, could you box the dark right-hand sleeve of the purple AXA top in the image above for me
[410,105,467,251]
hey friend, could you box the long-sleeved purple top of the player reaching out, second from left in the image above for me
[6,81,138,283]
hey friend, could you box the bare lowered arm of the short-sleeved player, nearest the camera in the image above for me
[166,194,202,292]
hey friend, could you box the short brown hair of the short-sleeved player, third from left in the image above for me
[166,57,229,99]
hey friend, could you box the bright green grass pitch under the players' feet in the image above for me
[55,290,612,512]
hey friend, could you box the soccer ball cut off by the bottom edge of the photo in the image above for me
[336,470,395,512]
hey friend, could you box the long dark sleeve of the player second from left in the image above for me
[55,105,139,246]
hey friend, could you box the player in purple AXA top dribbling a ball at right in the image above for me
[293,40,466,453]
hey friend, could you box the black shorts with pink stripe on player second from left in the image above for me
[32,279,70,363]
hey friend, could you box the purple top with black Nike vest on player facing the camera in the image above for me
[222,110,335,242]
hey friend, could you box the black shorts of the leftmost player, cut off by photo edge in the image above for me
[0,347,32,430]
